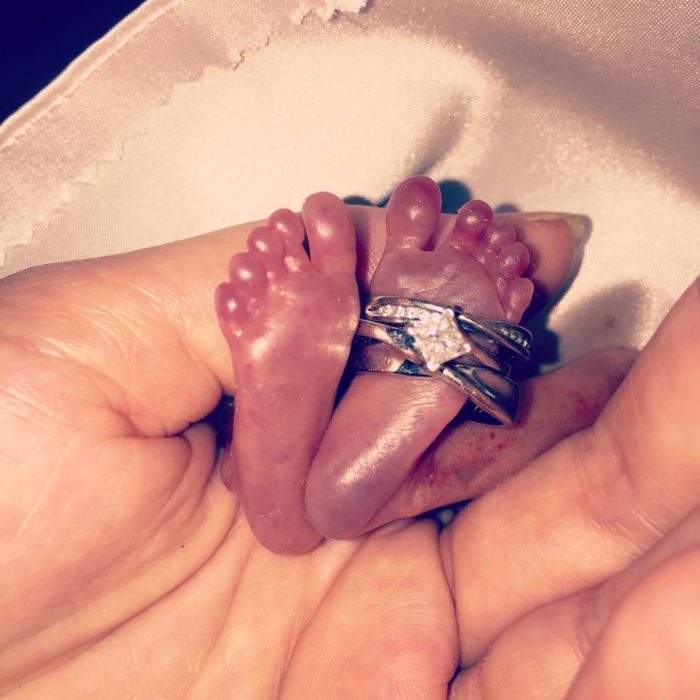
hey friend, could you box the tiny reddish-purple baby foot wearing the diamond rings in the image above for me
[306,177,533,538]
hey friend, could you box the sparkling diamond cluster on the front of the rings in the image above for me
[373,304,467,372]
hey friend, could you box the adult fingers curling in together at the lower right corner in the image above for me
[443,280,700,700]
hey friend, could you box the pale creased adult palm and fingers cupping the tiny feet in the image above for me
[0,205,700,700]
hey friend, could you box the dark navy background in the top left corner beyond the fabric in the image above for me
[0,0,143,123]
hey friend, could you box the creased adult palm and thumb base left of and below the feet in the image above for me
[0,211,697,699]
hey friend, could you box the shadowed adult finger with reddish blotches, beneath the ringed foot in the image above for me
[367,348,637,530]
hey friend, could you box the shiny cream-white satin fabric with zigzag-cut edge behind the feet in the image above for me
[0,0,700,359]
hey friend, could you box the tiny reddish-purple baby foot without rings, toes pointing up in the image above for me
[216,193,359,553]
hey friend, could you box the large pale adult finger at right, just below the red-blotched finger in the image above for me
[443,281,700,665]
